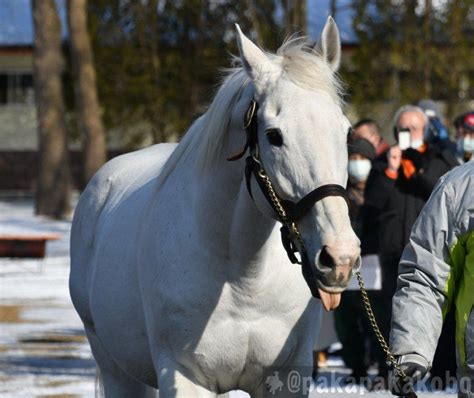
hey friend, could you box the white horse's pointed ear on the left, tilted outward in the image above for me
[235,24,274,82]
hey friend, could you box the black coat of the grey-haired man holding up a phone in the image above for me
[361,148,452,296]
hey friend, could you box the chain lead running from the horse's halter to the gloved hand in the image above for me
[258,169,417,398]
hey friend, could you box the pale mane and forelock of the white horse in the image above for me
[158,37,344,185]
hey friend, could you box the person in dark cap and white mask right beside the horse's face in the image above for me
[334,138,385,384]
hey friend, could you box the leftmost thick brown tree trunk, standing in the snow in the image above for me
[32,0,70,218]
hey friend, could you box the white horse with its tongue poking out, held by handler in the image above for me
[70,18,359,398]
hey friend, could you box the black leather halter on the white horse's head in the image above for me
[227,99,349,298]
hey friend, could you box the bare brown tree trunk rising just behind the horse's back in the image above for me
[67,0,107,184]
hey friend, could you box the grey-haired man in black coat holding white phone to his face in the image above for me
[361,105,452,388]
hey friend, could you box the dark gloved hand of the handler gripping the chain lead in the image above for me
[389,353,430,397]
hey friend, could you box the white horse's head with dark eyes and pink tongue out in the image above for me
[237,18,360,309]
